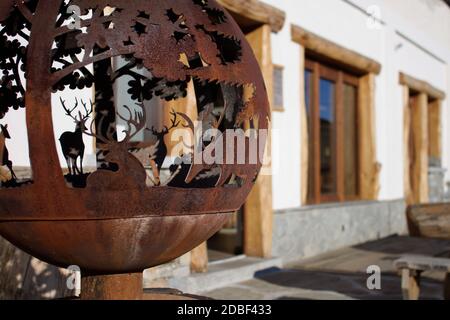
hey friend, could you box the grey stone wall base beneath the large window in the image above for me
[272,200,408,262]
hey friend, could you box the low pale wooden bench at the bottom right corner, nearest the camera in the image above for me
[394,255,450,300]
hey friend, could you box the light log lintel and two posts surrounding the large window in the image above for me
[291,24,382,204]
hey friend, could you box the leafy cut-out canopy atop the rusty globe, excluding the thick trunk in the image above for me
[0,0,246,119]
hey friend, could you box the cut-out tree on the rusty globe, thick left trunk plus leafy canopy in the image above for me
[0,0,264,188]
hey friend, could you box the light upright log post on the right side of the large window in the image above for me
[358,73,381,200]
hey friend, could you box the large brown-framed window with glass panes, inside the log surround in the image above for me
[304,60,359,203]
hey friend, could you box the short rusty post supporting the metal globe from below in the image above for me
[81,272,144,300]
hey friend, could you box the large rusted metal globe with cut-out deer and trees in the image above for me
[0,0,269,274]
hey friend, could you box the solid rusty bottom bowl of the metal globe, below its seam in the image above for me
[0,214,230,274]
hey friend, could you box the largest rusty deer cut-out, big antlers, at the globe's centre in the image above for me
[85,104,147,190]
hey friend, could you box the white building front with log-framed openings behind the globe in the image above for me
[151,0,450,291]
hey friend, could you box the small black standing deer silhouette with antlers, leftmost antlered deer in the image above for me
[59,98,93,175]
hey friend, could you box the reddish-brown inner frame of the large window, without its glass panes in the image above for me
[304,58,361,204]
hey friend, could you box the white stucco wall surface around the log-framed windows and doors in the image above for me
[264,0,450,210]
